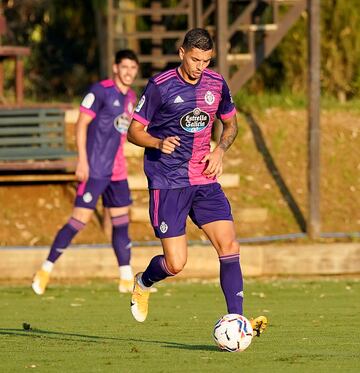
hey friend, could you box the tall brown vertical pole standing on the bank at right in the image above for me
[307,0,320,239]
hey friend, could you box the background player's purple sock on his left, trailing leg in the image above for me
[47,218,85,263]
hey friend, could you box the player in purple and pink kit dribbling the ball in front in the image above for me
[128,28,267,335]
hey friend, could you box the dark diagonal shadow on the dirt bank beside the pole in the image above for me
[243,111,306,232]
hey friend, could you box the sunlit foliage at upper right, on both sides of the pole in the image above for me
[250,0,360,101]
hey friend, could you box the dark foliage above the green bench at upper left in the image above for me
[3,0,98,101]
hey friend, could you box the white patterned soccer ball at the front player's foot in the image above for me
[213,313,253,352]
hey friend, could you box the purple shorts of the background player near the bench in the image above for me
[75,178,132,210]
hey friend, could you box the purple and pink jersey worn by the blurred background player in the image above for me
[80,80,136,180]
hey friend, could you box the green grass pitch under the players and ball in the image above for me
[0,278,360,373]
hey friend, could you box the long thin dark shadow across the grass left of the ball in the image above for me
[0,328,218,351]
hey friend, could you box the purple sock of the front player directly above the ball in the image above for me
[219,254,244,315]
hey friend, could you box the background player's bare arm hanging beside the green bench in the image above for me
[75,112,93,182]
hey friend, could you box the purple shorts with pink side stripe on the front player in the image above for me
[149,183,233,238]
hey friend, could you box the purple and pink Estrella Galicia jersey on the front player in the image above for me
[133,69,236,189]
